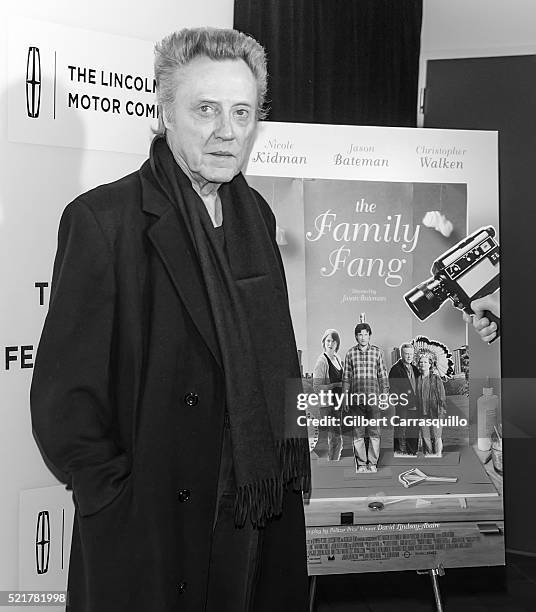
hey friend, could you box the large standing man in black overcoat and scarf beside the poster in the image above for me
[31,29,309,612]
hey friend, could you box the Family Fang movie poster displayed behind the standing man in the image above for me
[248,124,504,574]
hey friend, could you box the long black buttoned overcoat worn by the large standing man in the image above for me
[31,162,307,612]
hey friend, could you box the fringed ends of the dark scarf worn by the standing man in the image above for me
[235,438,311,527]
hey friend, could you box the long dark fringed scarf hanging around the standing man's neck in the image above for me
[151,136,310,526]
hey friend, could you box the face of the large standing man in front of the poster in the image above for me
[164,56,257,186]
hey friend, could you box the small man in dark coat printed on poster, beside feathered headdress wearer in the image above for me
[389,342,419,457]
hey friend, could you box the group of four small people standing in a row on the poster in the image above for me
[313,322,446,473]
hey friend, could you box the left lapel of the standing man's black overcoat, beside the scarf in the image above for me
[140,163,222,367]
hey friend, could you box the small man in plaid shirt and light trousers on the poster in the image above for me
[342,323,389,473]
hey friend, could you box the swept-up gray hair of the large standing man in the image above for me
[154,28,268,132]
